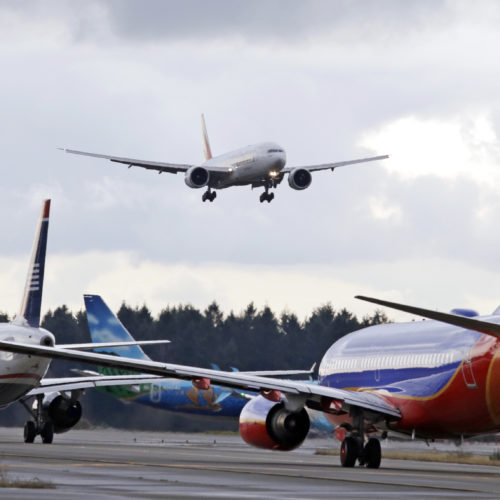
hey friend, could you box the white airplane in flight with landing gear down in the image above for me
[62,115,389,203]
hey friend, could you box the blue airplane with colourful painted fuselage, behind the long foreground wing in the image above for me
[81,295,333,432]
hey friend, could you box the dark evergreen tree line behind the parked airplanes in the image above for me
[0,302,389,430]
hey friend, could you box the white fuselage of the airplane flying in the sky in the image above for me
[202,142,286,189]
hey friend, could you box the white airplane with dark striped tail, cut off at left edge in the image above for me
[0,200,166,443]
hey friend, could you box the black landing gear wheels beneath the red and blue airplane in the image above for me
[340,408,382,469]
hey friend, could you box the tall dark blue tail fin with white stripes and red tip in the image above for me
[12,200,50,328]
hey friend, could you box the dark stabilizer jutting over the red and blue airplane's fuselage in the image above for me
[355,295,500,338]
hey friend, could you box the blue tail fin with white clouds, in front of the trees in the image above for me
[83,295,151,359]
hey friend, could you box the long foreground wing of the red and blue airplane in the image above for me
[0,341,401,418]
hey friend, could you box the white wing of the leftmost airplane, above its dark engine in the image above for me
[24,374,164,398]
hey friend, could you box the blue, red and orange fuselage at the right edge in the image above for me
[319,316,500,437]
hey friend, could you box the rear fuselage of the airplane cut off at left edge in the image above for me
[0,323,54,407]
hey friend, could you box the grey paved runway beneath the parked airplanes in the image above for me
[0,428,500,500]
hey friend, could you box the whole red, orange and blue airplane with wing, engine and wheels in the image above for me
[0,286,500,468]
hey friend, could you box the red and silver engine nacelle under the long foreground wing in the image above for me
[240,396,309,451]
